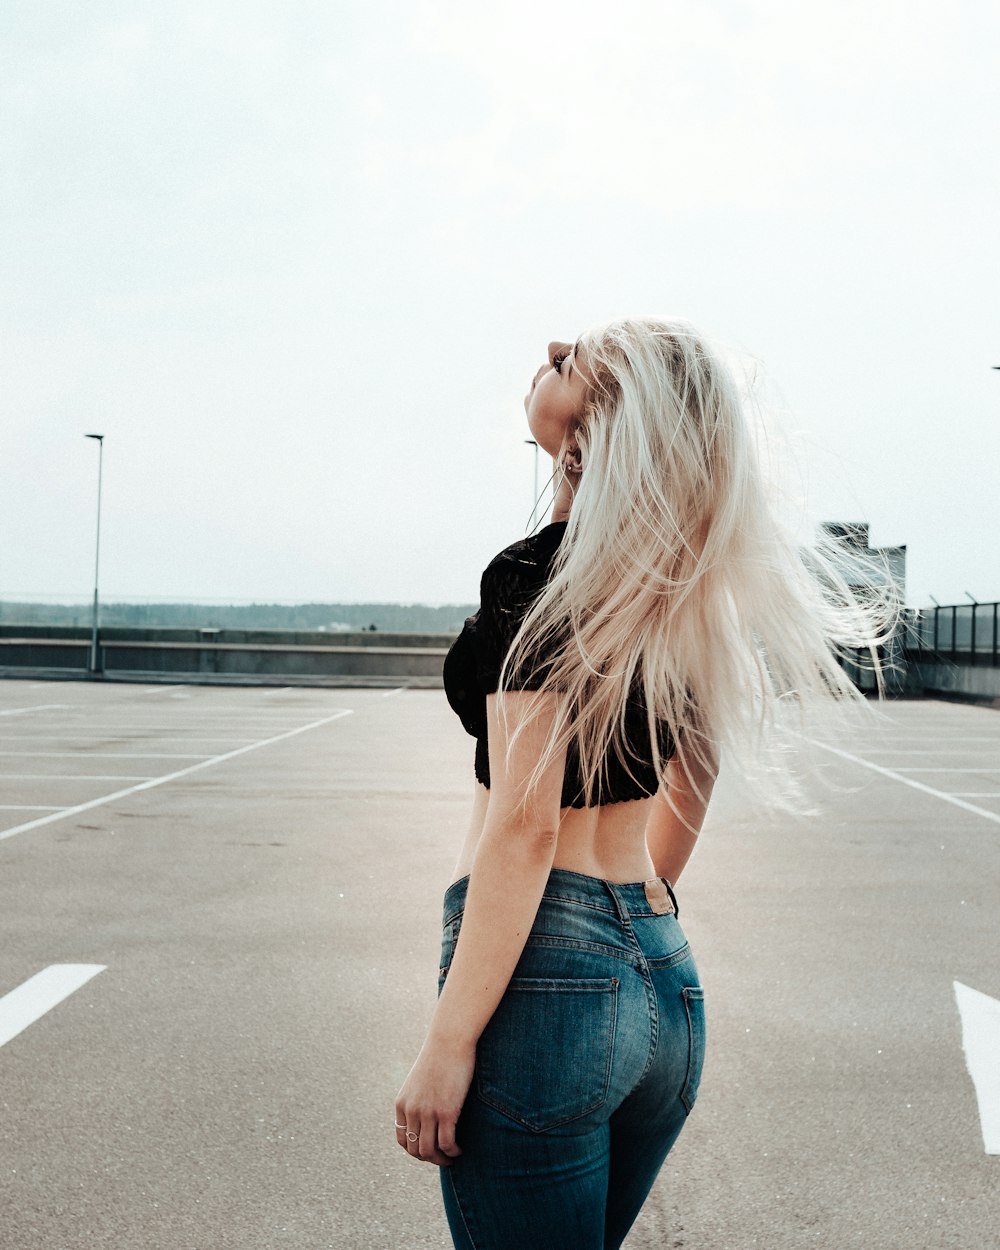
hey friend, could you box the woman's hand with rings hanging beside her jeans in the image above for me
[396,1036,476,1168]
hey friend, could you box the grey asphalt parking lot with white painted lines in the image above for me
[0,680,1000,1250]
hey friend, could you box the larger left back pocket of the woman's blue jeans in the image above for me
[476,976,619,1133]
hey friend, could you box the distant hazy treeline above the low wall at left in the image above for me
[0,600,476,634]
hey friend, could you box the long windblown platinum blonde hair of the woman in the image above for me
[500,318,896,801]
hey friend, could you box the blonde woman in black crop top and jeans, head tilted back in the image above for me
[395,319,879,1250]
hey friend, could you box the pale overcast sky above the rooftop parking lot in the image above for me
[0,0,1000,605]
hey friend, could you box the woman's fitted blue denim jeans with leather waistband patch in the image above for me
[439,869,705,1250]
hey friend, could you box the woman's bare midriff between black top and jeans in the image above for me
[453,783,656,881]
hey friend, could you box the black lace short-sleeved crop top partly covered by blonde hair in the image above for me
[444,521,673,808]
